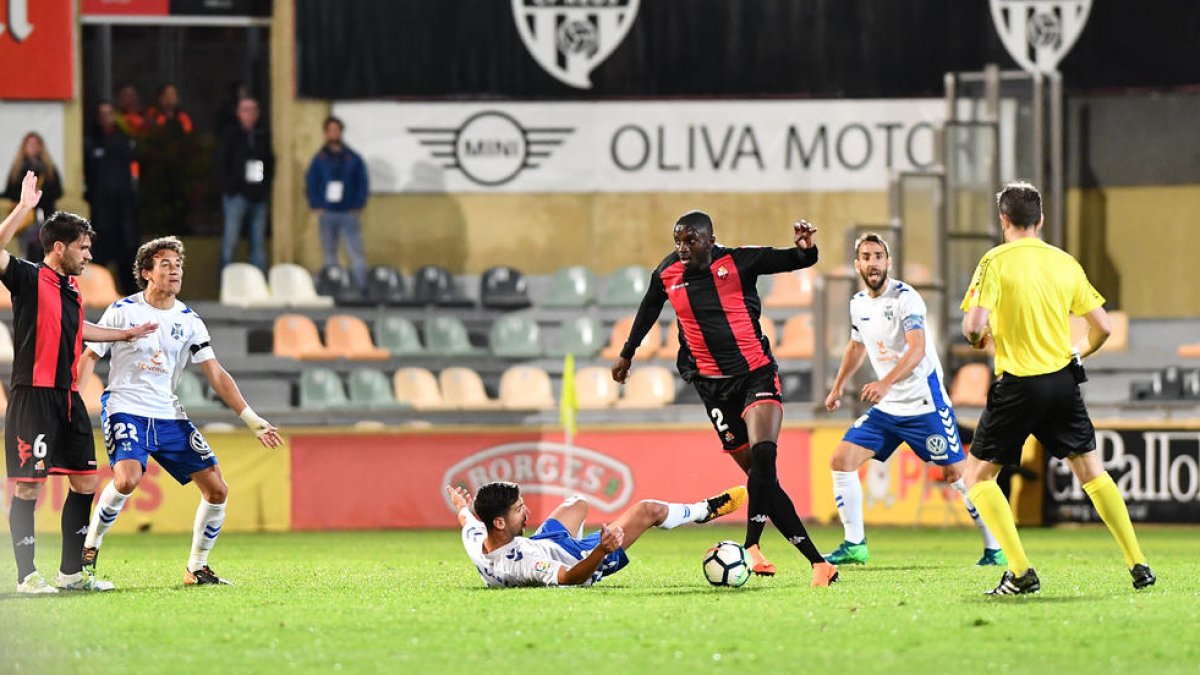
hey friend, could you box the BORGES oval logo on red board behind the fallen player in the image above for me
[440,441,634,512]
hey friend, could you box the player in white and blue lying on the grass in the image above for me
[446,483,746,589]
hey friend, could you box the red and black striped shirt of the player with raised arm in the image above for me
[0,256,84,389]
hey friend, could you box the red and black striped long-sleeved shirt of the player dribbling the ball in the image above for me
[620,246,817,381]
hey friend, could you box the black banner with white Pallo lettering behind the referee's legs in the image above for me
[1046,429,1200,522]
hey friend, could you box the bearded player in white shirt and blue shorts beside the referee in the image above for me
[826,233,1008,566]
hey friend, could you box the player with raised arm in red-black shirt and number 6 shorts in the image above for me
[0,172,157,593]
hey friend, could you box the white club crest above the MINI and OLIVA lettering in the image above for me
[512,0,640,89]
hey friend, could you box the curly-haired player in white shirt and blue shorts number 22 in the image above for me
[80,237,283,585]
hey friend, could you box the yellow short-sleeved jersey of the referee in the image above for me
[961,237,1104,377]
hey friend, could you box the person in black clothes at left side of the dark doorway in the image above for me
[83,101,138,295]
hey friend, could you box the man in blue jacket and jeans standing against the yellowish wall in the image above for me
[305,117,368,291]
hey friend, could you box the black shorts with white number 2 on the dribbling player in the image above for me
[692,364,784,453]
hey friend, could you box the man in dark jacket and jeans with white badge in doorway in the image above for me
[212,97,275,274]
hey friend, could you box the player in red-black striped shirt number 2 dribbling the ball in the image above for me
[612,211,838,586]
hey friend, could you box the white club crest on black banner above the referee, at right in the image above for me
[990,0,1092,73]
